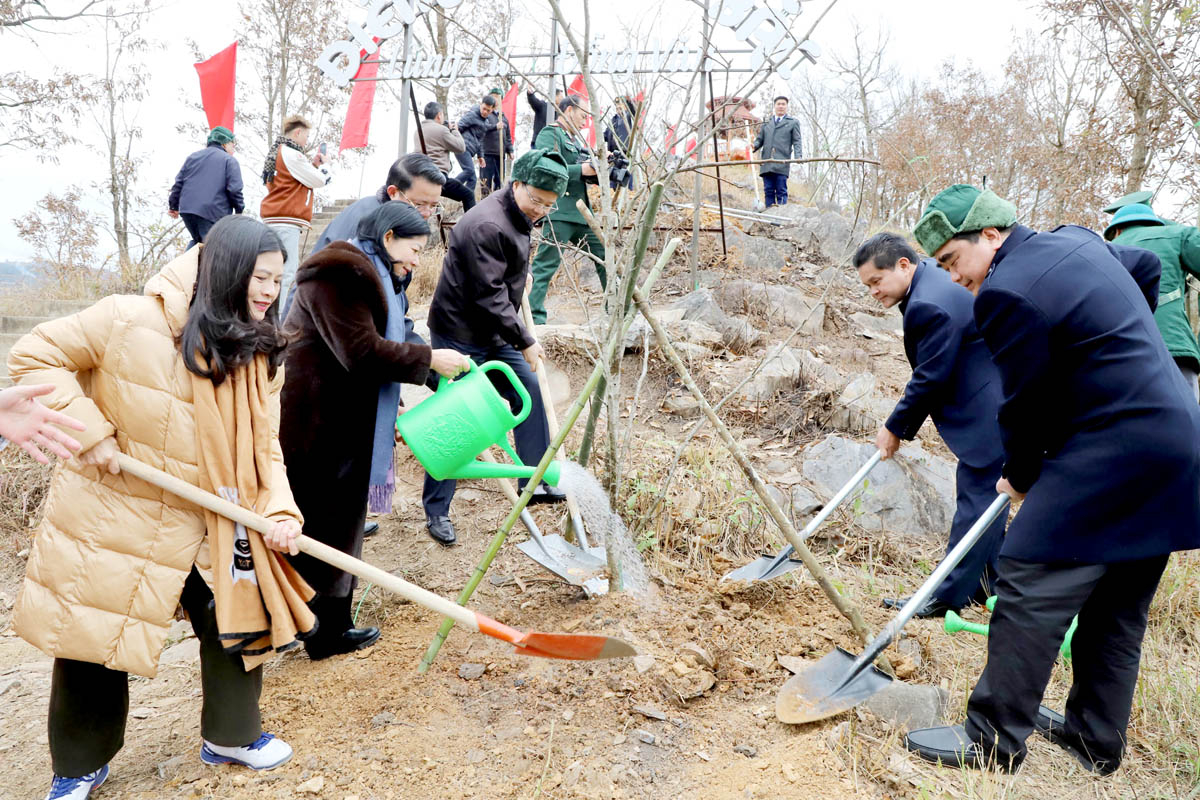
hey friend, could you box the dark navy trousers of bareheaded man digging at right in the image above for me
[934,458,1008,608]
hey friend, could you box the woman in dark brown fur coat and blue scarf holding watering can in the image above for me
[280,203,468,660]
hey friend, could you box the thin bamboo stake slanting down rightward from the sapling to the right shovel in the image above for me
[634,289,894,675]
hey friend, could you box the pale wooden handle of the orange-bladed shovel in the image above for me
[116,453,479,631]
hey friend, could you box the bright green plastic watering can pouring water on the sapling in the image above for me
[396,361,560,486]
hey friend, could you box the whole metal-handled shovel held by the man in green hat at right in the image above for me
[775,494,1008,723]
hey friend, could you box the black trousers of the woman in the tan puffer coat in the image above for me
[48,570,263,777]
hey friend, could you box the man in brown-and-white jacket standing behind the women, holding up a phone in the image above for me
[258,116,329,307]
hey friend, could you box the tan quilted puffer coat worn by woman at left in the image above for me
[8,247,301,676]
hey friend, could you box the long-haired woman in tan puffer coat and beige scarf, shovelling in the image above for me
[8,217,314,799]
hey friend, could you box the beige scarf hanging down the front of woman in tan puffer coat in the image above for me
[192,355,316,670]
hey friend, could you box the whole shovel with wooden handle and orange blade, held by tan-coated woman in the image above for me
[116,453,637,661]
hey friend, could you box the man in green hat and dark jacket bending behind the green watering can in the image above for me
[422,150,566,546]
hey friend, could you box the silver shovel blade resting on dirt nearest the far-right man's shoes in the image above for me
[775,648,892,724]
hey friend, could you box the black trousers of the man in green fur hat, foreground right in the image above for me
[966,555,1168,771]
